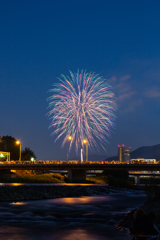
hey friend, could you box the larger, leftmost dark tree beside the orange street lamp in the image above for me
[0,135,19,160]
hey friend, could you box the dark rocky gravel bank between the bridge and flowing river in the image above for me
[0,184,138,202]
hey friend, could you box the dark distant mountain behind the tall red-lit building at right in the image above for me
[106,144,160,161]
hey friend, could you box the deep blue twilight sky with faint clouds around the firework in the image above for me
[0,0,160,160]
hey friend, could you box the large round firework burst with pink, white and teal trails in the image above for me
[47,70,116,152]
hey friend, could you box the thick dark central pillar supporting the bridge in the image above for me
[68,169,86,183]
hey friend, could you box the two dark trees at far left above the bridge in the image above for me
[0,135,36,161]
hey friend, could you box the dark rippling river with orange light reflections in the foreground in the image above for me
[0,190,145,240]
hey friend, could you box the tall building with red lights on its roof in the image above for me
[118,144,131,162]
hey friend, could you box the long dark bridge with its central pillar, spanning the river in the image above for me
[0,163,160,183]
